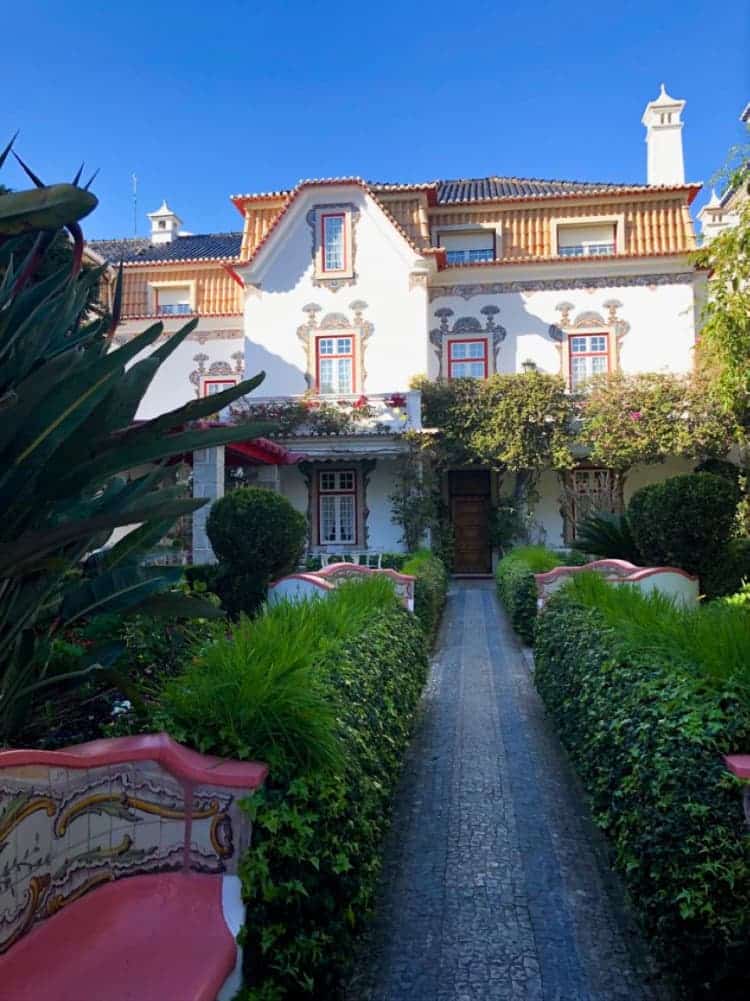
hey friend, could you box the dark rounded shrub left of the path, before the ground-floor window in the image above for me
[206,486,307,616]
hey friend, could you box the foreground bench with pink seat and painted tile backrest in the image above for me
[0,734,267,1001]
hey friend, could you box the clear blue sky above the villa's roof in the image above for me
[0,0,750,238]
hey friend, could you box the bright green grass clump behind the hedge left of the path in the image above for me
[161,578,396,774]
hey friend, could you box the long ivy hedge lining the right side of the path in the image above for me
[535,594,750,1001]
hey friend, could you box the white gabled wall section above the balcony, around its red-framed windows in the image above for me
[237,185,428,396]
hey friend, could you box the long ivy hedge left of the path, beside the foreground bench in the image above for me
[240,608,427,1001]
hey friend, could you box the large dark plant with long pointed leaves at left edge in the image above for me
[0,142,268,743]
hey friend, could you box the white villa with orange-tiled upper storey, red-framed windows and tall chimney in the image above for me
[92,88,703,574]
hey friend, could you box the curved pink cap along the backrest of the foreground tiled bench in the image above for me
[0,734,268,790]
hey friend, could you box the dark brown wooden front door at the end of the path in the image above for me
[451,470,492,574]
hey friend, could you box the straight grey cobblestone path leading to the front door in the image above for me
[348,582,663,1001]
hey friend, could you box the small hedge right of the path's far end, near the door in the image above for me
[495,546,586,644]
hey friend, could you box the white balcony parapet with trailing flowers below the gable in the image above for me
[228,389,422,436]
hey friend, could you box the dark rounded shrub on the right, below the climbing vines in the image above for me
[628,472,740,579]
